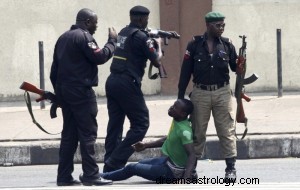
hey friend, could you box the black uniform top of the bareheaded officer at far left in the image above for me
[50,25,116,89]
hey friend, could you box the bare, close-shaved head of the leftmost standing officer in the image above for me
[76,8,98,35]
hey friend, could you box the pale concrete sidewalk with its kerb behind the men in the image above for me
[0,92,300,165]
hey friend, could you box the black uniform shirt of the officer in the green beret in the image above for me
[178,33,237,98]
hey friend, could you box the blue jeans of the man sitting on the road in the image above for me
[101,157,173,181]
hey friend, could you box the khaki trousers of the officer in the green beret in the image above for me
[191,85,237,158]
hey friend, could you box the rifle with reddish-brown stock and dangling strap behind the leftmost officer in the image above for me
[20,82,59,135]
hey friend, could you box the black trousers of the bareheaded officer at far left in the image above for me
[56,86,99,181]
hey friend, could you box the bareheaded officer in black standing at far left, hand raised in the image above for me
[50,8,117,186]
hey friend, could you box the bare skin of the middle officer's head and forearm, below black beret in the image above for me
[130,15,163,68]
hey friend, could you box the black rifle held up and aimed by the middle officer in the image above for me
[146,28,180,80]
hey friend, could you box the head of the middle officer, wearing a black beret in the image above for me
[129,5,150,29]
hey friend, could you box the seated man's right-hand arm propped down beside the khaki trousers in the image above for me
[183,143,197,179]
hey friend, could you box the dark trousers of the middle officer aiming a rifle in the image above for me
[104,74,149,168]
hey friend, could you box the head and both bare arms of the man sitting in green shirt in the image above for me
[132,100,197,178]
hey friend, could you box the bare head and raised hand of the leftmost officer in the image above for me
[76,10,118,39]
